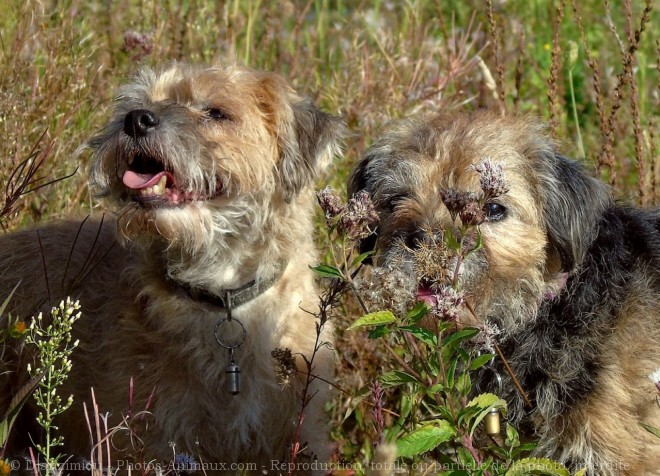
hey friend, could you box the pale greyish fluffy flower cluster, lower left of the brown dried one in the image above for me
[355,266,417,316]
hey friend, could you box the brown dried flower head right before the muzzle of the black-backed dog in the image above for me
[408,231,451,287]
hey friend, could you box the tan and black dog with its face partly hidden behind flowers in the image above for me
[349,111,660,475]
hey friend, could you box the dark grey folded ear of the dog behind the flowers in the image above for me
[534,151,612,272]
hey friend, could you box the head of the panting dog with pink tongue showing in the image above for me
[87,64,343,253]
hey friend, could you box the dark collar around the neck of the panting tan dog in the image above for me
[167,262,287,309]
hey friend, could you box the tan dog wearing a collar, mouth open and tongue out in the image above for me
[0,63,345,464]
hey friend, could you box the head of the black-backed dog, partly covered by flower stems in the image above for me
[349,112,610,328]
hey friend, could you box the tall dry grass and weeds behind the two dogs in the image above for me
[0,0,660,470]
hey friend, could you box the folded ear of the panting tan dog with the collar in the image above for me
[255,75,346,201]
